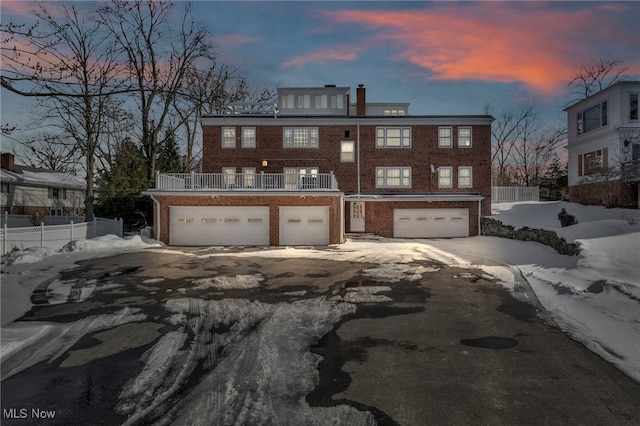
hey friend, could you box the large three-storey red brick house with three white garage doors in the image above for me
[146,85,493,245]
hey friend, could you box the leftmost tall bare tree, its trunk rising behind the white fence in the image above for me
[1,0,126,220]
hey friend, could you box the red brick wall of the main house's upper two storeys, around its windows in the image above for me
[202,117,491,215]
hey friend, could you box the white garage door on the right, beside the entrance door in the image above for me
[393,209,469,238]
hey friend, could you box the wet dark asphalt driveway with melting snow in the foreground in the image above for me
[1,248,640,425]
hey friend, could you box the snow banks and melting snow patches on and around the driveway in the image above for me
[1,202,640,398]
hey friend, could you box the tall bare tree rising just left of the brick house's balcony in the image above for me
[99,0,213,180]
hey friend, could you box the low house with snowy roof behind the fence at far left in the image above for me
[0,153,86,217]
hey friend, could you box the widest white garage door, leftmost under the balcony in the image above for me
[169,206,269,246]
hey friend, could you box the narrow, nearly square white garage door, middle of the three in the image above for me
[280,206,329,246]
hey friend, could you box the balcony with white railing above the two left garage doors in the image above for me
[155,172,338,192]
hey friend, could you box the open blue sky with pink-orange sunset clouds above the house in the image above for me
[0,1,640,130]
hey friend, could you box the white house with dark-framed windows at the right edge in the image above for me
[565,81,640,207]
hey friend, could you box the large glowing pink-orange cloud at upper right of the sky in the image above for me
[325,3,637,95]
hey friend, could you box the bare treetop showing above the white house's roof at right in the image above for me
[568,58,629,104]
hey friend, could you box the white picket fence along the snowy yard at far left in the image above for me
[0,218,123,255]
